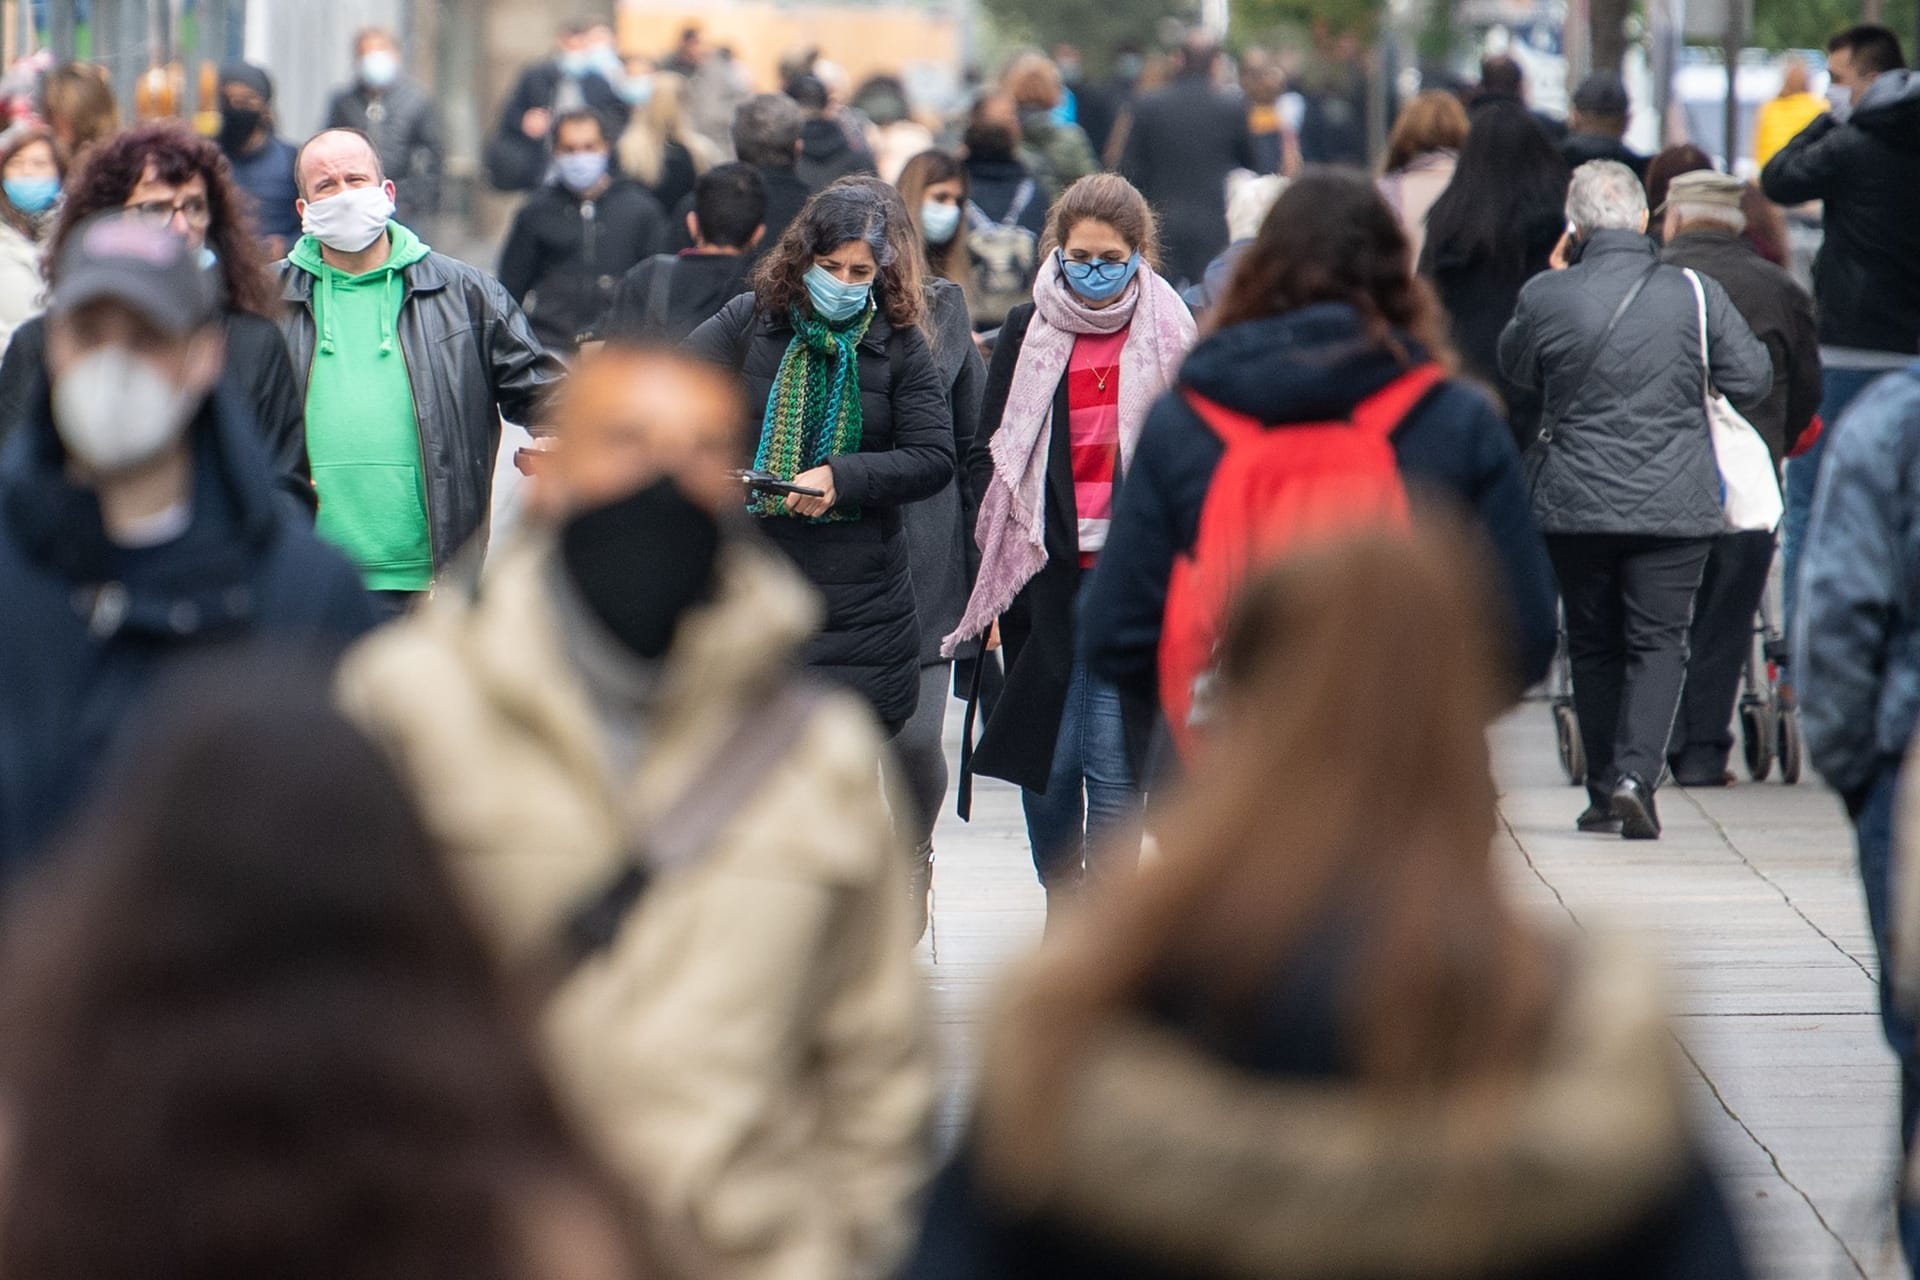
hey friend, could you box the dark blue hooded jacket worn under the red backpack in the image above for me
[1079,303,1555,699]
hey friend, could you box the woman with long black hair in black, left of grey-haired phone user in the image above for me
[1419,102,1572,451]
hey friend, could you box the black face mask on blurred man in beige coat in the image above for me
[561,478,720,660]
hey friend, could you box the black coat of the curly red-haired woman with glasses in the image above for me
[0,311,317,514]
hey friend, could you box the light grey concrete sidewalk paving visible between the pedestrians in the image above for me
[925,704,1903,1280]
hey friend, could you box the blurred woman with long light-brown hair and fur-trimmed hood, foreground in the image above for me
[904,533,1745,1280]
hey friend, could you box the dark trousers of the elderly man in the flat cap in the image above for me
[1667,532,1774,781]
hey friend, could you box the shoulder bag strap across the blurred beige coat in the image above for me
[540,681,822,992]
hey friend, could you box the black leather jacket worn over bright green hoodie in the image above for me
[275,253,566,572]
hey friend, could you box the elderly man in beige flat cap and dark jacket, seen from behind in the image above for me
[1663,169,1820,787]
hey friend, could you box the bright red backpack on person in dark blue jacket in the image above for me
[1160,365,1446,758]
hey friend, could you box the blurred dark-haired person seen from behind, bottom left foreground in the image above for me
[0,668,660,1280]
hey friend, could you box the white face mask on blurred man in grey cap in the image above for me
[54,347,200,474]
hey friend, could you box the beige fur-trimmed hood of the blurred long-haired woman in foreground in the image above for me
[975,924,1693,1280]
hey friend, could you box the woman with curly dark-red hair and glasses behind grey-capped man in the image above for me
[0,121,313,509]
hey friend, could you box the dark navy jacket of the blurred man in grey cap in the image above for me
[0,378,372,890]
